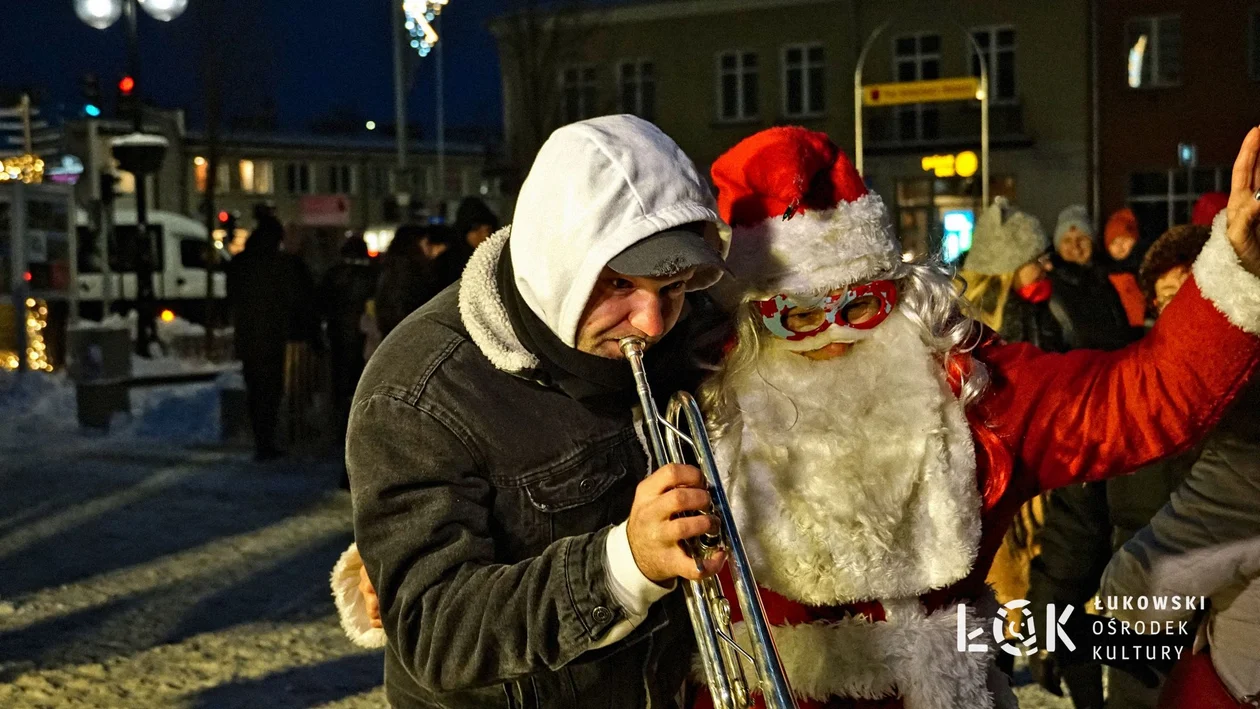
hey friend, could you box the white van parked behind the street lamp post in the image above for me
[78,207,228,322]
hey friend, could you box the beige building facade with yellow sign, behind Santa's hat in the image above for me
[494,0,1090,260]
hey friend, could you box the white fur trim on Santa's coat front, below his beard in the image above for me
[693,599,1009,709]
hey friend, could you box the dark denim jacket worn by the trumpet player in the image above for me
[347,230,693,709]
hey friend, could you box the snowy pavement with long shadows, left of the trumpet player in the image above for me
[0,378,1071,709]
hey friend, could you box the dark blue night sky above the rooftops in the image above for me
[0,0,510,135]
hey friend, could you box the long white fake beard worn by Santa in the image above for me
[716,311,980,606]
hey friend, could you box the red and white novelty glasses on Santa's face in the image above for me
[755,281,897,343]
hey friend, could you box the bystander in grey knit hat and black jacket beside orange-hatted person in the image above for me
[1050,204,1140,350]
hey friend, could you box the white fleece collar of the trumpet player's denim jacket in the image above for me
[460,224,538,374]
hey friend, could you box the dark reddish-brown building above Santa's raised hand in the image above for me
[1097,0,1260,242]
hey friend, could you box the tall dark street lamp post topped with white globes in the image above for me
[74,0,188,356]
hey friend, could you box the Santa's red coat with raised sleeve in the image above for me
[696,280,1260,709]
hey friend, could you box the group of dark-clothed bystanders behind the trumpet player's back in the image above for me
[228,196,499,470]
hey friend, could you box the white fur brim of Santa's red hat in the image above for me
[726,194,901,300]
